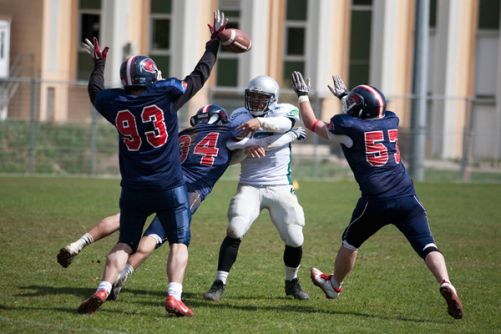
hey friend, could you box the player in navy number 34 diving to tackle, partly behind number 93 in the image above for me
[57,104,305,300]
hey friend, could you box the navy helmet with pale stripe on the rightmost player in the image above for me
[345,85,386,118]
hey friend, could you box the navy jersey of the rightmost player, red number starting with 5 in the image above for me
[329,111,415,198]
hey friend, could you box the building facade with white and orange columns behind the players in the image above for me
[0,0,501,160]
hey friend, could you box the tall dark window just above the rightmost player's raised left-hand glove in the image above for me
[282,0,308,87]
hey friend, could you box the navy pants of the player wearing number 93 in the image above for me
[119,185,191,251]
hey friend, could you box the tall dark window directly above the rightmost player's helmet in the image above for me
[348,0,372,87]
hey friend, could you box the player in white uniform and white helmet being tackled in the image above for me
[204,76,309,301]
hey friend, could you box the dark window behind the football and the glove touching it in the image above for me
[216,0,240,87]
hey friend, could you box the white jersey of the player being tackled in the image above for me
[230,103,299,186]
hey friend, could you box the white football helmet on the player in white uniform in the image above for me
[245,75,279,117]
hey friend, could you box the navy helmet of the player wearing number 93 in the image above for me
[120,56,161,88]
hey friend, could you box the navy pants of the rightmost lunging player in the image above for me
[343,195,438,258]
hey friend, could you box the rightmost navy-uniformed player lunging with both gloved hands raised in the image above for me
[292,72,463,319]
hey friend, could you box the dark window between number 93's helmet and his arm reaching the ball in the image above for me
[150,0,172,77]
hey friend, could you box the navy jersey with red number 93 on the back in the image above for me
[94,78,186,190]
